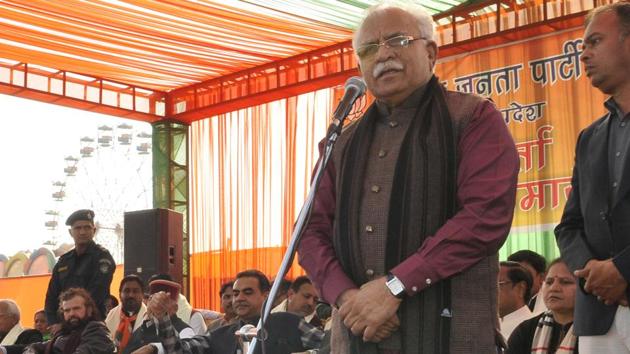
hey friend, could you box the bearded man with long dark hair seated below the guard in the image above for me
[6,288,115,354]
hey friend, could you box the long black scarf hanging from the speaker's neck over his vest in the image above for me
[333,76,457,354]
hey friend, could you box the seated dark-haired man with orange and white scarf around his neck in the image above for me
[105,274,147,353]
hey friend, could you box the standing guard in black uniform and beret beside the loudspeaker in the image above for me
[44,209,116,333]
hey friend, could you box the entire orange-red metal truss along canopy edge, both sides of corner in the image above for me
[0,0,611,123]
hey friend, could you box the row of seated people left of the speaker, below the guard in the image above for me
[0,270,330,354]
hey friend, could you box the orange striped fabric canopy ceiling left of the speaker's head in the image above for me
[0,0,352,91]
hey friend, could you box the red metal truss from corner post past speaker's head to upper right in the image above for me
[167,0,610,122]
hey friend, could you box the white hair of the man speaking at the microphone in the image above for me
[352,0,435,49]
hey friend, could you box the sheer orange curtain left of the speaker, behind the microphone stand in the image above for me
[190,89,335,310]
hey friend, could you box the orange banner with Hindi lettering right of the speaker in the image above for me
[436,28,605,234]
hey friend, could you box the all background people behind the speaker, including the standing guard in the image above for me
[0,210,578,354]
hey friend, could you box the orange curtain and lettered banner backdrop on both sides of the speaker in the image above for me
[190,28,605,309]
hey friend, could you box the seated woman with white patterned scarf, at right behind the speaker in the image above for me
[506,258,578,354]
